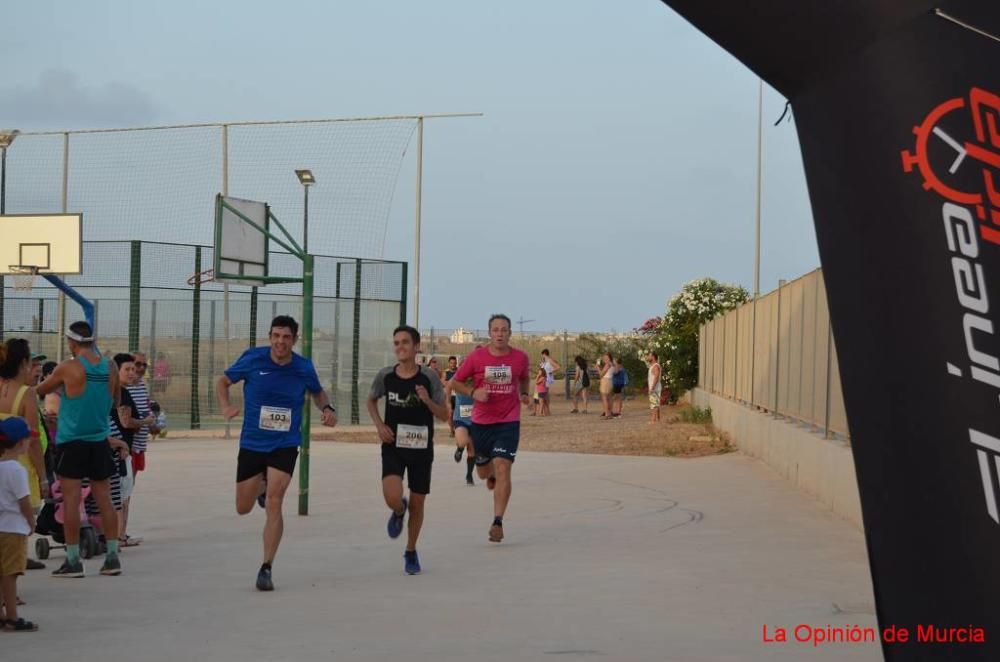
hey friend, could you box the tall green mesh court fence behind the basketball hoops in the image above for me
[0,241,407,428]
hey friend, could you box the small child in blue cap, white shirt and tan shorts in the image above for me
[0,416,38,632]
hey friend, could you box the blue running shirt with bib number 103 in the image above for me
[226,347,323,453]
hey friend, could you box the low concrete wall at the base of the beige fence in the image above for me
[691,389,862,529]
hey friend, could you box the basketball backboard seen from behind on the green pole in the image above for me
[214,196,270,285]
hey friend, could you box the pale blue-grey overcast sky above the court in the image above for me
[0,0,818,331]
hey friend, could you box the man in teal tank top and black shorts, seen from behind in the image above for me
[37,322,122,577]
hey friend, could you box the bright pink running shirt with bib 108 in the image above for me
[454,347,529,425]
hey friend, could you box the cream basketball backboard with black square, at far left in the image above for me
[0,214,83,275]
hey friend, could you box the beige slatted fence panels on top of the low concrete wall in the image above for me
[698,269,849,438]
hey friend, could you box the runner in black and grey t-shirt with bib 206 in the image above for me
[368,326,448,575]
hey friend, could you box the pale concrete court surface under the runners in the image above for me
[9,438,881,662]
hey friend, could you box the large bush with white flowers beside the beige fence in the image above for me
[636,278,750,398]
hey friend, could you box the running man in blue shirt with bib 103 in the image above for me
[215,315,337,591]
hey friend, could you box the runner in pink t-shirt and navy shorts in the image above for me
[451,315,531,542]
